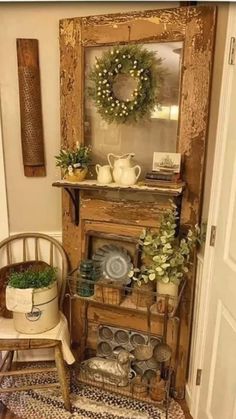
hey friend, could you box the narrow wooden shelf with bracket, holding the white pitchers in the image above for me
[52,180,185,225]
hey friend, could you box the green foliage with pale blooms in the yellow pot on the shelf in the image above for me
[55,142,91,173]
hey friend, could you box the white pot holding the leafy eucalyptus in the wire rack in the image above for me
[157,281,179,313]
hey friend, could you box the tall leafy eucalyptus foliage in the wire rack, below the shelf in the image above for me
[129,202,201,285]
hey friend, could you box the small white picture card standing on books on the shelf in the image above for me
[152,152,181,173]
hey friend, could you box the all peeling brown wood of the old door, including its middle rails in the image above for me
[60,6,215,393]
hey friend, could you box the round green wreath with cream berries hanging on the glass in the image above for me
[88,45,165,124]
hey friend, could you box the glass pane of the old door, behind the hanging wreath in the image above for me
[84,42,183,176]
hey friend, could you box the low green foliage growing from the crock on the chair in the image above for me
[8,267,57,289]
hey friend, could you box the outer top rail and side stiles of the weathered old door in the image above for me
[60,6,216,397]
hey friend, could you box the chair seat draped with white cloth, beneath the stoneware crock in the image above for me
[0,312,75,364]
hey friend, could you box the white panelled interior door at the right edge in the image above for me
[197,5,236,419]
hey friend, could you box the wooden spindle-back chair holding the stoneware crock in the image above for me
[0,233,71,410]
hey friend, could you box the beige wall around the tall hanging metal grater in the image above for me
[0,2,178,232]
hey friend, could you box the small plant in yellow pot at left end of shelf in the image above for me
[55,142,91,182]
